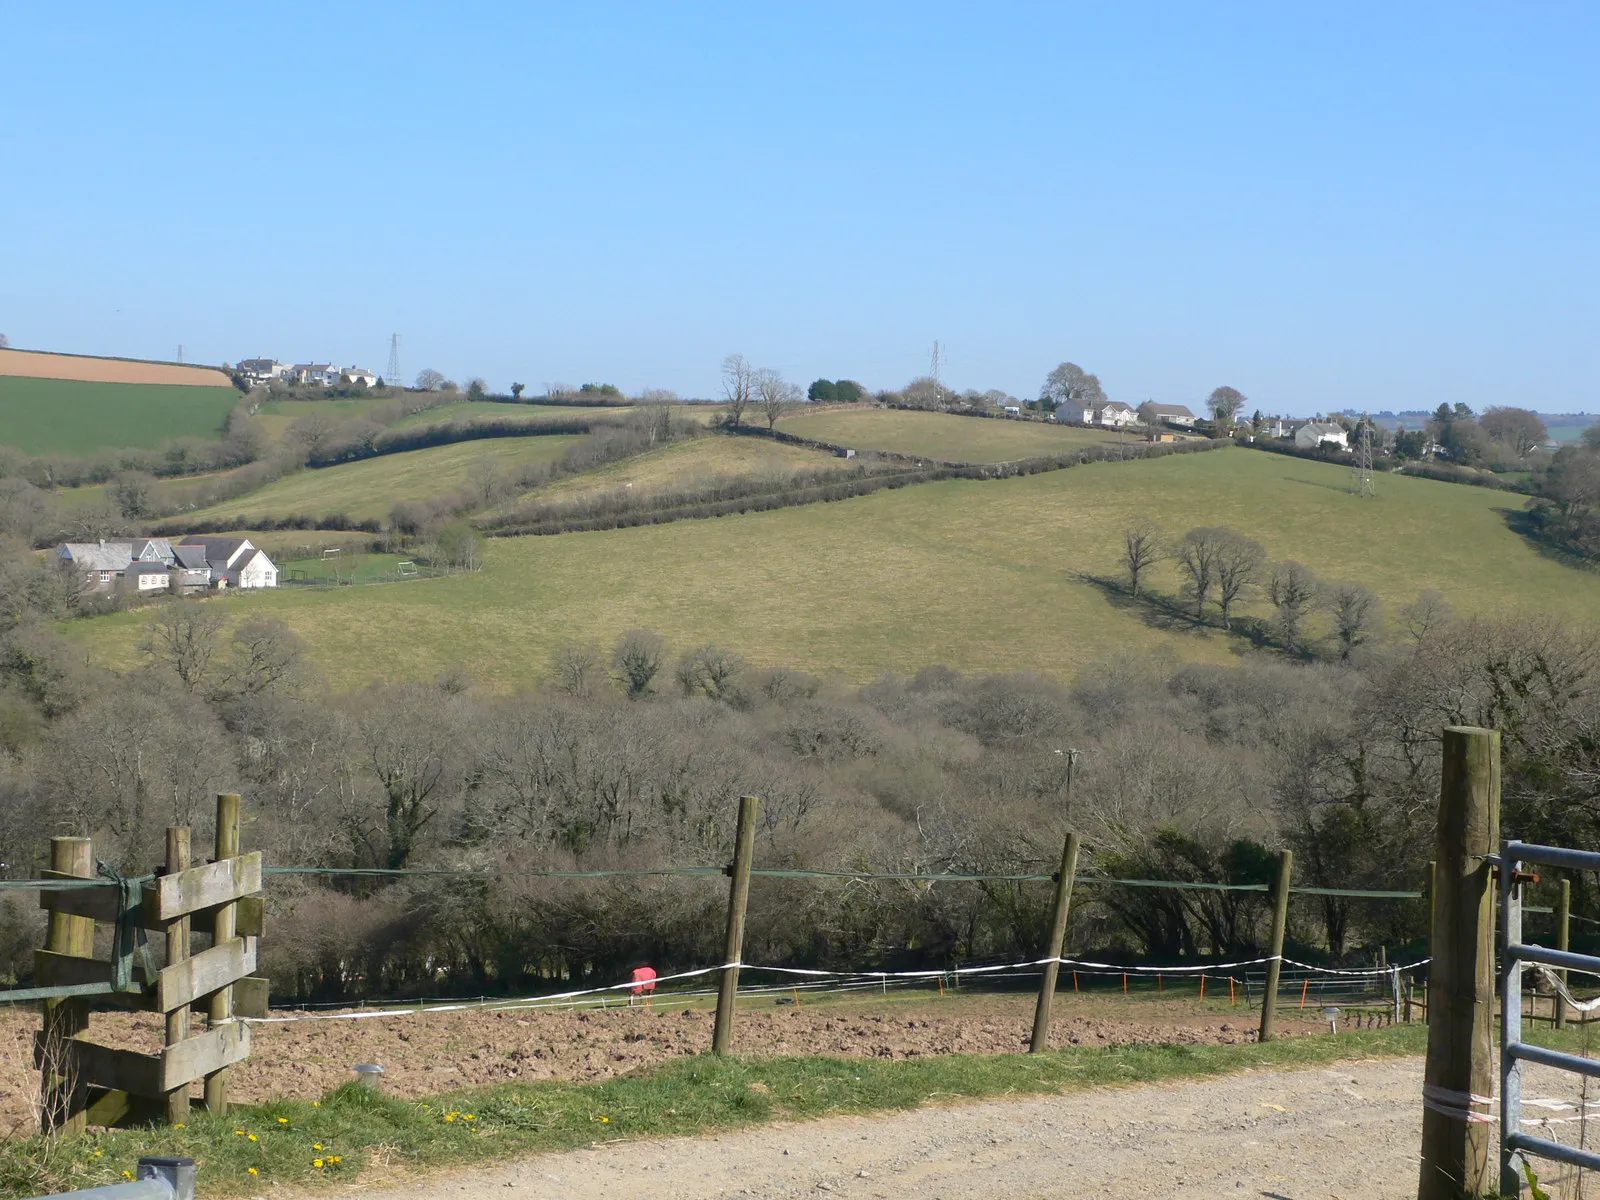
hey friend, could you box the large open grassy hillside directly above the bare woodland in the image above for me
[69,444,1600,686]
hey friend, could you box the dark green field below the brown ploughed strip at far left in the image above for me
[0,374,238,454]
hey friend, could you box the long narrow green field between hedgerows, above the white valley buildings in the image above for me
[173,435,578,522]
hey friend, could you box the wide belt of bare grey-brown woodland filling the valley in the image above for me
[0,563,1600,1000]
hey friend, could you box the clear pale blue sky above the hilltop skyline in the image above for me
[0,2,1600,413]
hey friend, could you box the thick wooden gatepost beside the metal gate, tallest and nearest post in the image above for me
[1418,726,1501,1200]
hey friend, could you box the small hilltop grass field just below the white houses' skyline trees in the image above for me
[779,408,1131,462]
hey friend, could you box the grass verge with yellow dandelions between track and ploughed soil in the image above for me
[0,1024,1427,1195]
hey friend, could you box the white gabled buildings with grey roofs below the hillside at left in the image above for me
[56,536,278,595]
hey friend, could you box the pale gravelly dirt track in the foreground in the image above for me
[344,1059,1422,1200]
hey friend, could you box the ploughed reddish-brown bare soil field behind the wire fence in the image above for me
[0,995,1326,1130]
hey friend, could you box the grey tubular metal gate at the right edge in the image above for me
[1499,842,1600,1195]
